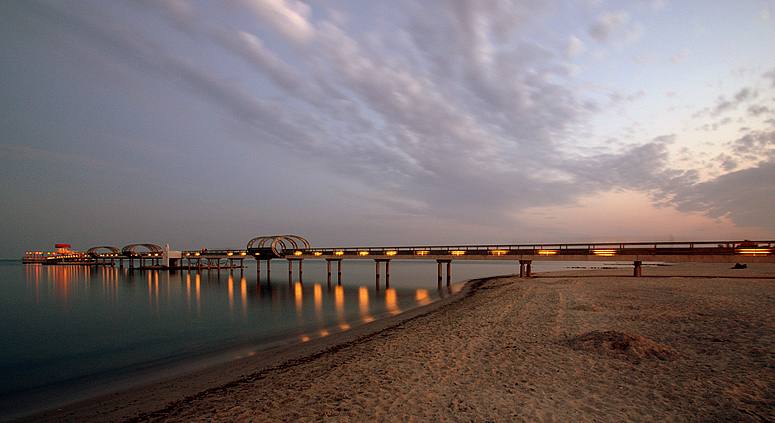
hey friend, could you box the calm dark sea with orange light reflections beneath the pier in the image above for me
[0,259,632,421]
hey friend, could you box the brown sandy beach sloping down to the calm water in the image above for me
[22,263,775,422]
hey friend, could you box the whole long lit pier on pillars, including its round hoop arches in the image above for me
[34,235,775,286]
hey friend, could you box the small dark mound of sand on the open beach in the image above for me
[568,330,678,361]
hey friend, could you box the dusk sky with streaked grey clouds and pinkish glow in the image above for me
[0,0,775,258]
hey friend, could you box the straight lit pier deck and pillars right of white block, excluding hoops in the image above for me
[182,240,775,286]
